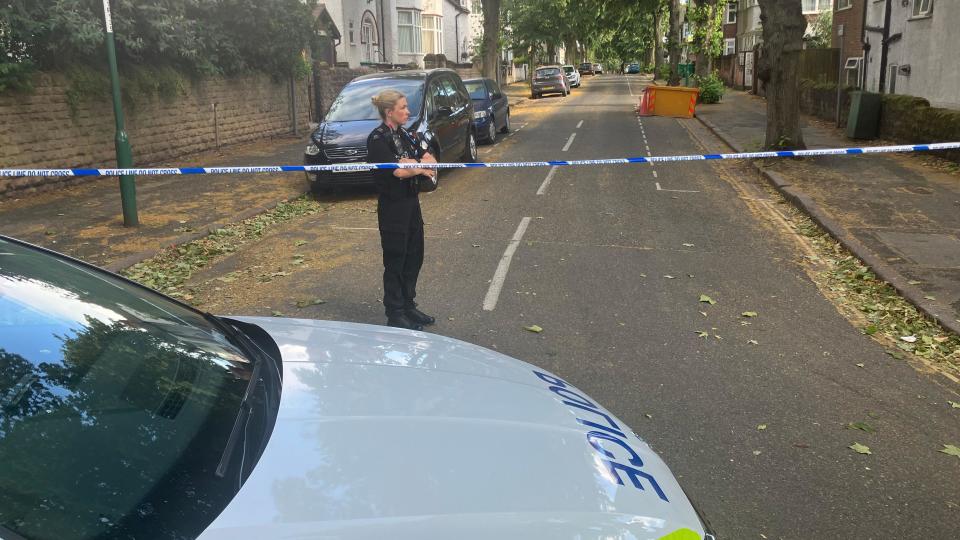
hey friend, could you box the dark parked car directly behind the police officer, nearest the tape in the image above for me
[304,69,477,193]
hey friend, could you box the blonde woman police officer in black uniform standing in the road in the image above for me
[367,90,437,330]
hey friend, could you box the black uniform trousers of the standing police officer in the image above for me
[377,196,423,317]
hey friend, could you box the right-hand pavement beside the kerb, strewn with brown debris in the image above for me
[697,89,960,333]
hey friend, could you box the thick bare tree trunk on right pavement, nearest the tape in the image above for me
[757,0,807,149]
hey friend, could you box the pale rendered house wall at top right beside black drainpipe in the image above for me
[864,0,960,109]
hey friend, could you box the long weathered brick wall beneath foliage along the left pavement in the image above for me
[0,74,312,197]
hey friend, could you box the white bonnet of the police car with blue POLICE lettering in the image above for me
[202,318,703,539]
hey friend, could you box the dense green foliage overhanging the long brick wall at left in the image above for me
[0,0,316,96]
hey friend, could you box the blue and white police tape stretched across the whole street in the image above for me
[0,142,960,177]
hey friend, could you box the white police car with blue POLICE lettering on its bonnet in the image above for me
[0,237,712,540]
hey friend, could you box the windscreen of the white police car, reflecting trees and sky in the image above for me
[0,238,253,539]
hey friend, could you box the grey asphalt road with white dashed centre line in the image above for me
[192,75,960,539]
